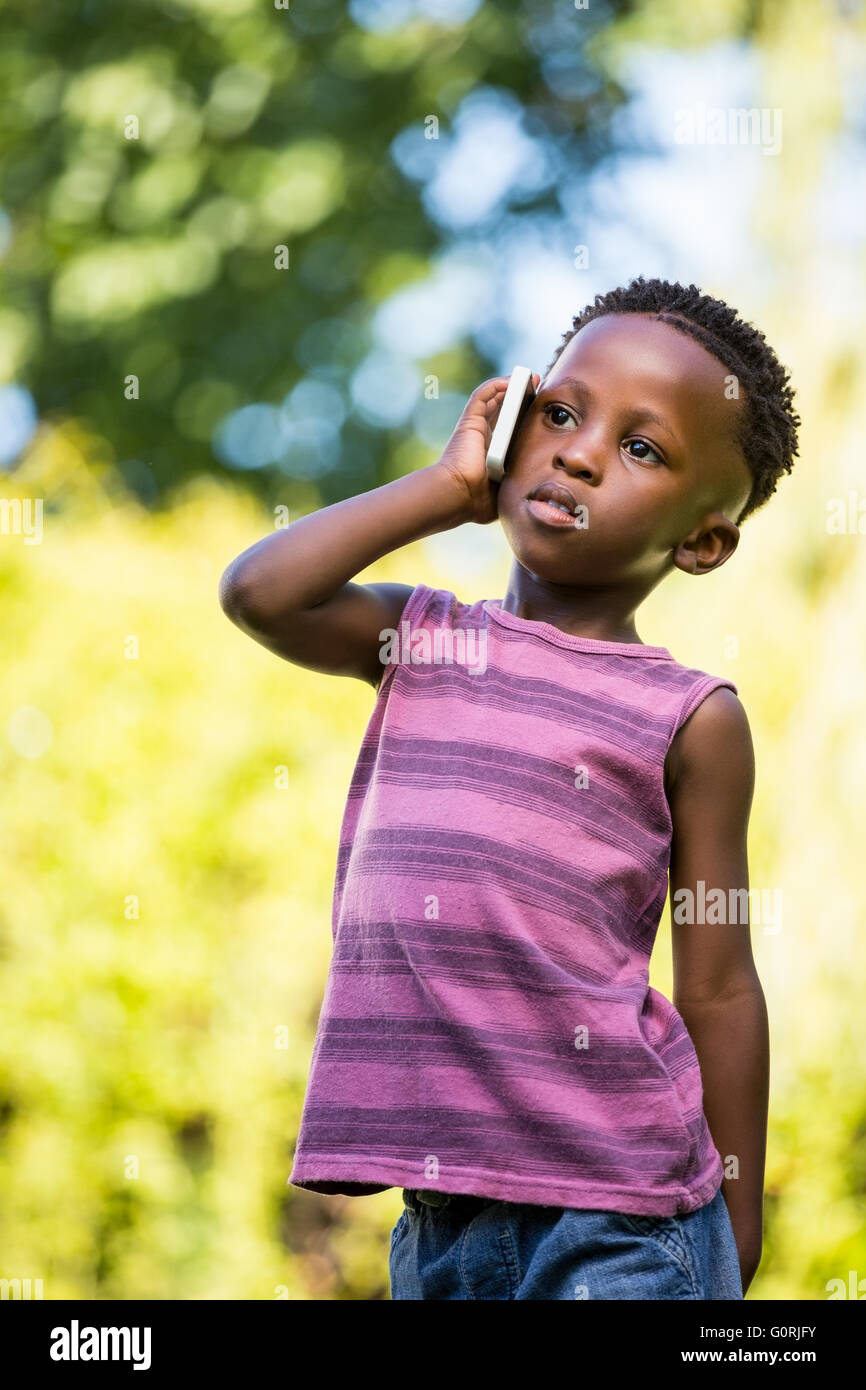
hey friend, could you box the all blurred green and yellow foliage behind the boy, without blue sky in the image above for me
[0,0,866,1300]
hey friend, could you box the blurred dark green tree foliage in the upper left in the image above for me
[0,0,628,506]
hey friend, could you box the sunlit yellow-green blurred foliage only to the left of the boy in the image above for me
[0,450,393,1298]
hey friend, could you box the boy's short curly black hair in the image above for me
[542,275,802,525]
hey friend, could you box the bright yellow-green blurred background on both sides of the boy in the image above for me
[0,3,866,1300]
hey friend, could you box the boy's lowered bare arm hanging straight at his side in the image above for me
[664,688,770,1294]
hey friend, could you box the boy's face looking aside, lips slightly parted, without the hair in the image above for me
[498,314,752,587]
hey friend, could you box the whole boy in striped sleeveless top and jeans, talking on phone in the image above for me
[221,278,799,1300]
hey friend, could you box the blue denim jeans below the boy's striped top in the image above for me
[389,1188,742,1300]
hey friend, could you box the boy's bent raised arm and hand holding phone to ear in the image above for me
[220,377,517,687]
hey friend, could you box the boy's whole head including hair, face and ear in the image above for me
[498,278,801,592]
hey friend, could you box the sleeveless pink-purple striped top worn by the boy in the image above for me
[289,584,737,1216]
